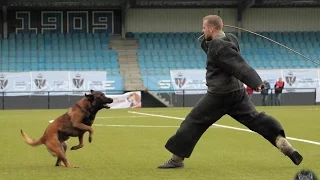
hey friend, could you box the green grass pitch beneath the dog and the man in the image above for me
[0,106,320,180]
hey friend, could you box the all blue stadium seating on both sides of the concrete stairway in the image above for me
[0,32,320,90]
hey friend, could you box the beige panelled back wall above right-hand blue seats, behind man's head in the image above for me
[126,7,320,32]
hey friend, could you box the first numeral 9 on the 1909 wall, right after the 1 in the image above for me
[41,11,63,33]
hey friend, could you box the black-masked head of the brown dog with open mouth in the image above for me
[85,90,113,109]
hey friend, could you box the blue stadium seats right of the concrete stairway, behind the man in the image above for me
[133,32,320,89]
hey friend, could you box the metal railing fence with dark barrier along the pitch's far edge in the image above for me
[0,88,320,110]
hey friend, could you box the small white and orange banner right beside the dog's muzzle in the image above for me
[106,91,141,109]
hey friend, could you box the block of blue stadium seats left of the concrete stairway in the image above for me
[0,33,123,93]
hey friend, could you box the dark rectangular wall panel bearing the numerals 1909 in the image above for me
[8,9,122,34]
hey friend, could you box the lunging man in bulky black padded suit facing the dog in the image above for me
[158,15,303,169]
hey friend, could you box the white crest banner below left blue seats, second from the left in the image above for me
[31,71,69,96]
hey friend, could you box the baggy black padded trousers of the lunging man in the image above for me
[165,89,285,158]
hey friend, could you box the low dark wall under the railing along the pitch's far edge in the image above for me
[0,91,319,111]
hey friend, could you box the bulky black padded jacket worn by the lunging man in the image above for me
[201,33,263,94]
